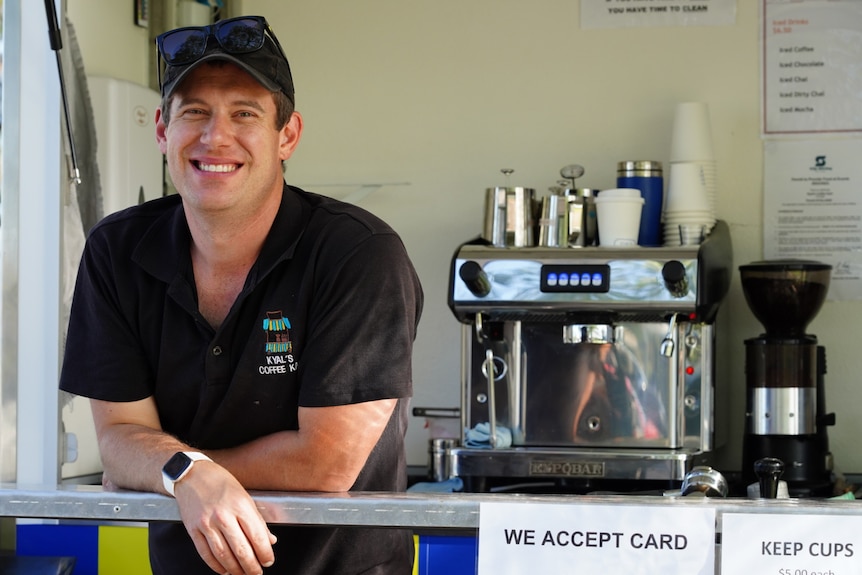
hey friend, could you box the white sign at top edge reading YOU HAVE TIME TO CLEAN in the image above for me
[581,0,736,29]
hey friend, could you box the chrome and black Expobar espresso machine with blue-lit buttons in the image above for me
[448,221,732,492]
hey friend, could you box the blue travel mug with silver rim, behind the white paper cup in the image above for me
[617,160,664,247]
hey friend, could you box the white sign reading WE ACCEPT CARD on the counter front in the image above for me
[478,502,715,575]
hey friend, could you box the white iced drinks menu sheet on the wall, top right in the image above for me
[762,0,862,136]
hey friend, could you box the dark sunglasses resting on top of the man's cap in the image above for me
[156,16,287,90]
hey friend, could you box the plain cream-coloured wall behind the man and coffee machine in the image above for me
[69,0,862,473]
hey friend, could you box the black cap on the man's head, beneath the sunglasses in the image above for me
[162,36,295,103]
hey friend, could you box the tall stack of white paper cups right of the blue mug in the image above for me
[663,102,716,246]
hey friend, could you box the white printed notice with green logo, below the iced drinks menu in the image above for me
[763,138,862,301]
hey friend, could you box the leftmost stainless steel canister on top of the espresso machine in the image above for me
[482,187,536,248]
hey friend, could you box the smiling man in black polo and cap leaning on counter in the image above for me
[60,16,422,575]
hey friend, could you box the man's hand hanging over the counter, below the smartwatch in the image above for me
[175,461,275,575]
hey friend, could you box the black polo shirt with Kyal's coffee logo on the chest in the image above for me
[60,185,422,575]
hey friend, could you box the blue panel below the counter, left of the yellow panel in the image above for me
[15,525,99,575]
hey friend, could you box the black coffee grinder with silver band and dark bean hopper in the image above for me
[739,260,835,497]
